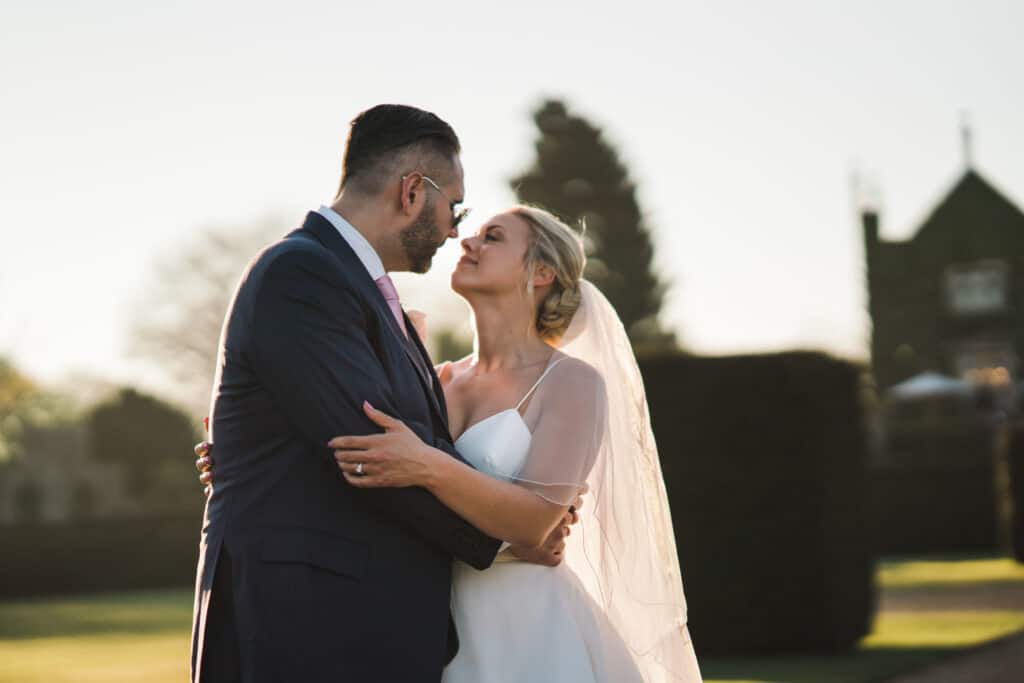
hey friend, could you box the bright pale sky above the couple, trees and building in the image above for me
[0,0,1024,395]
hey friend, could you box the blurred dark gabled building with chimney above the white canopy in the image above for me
[861,164,1024,391]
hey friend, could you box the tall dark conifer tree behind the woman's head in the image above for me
[511,99,677,350]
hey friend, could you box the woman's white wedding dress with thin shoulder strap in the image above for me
[442,356,700,683]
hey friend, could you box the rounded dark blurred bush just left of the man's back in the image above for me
[87,388,200,512]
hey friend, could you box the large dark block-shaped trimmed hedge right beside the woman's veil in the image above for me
[640,352,874,654]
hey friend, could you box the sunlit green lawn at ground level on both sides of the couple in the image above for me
[0,558,1024,683]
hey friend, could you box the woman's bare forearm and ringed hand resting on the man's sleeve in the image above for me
[330,404,569,548]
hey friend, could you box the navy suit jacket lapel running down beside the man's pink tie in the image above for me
[301,216,451,432]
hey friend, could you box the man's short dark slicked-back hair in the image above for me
[338,104,461,195]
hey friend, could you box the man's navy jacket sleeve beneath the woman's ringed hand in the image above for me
[252,249,501,569]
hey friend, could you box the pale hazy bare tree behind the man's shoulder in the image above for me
[132,218,282,417]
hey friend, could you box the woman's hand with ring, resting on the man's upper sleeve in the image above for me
[328,401,437,488]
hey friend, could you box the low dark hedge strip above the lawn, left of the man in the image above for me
[0,515,202,598]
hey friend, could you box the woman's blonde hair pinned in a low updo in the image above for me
[509,206,587,343]
